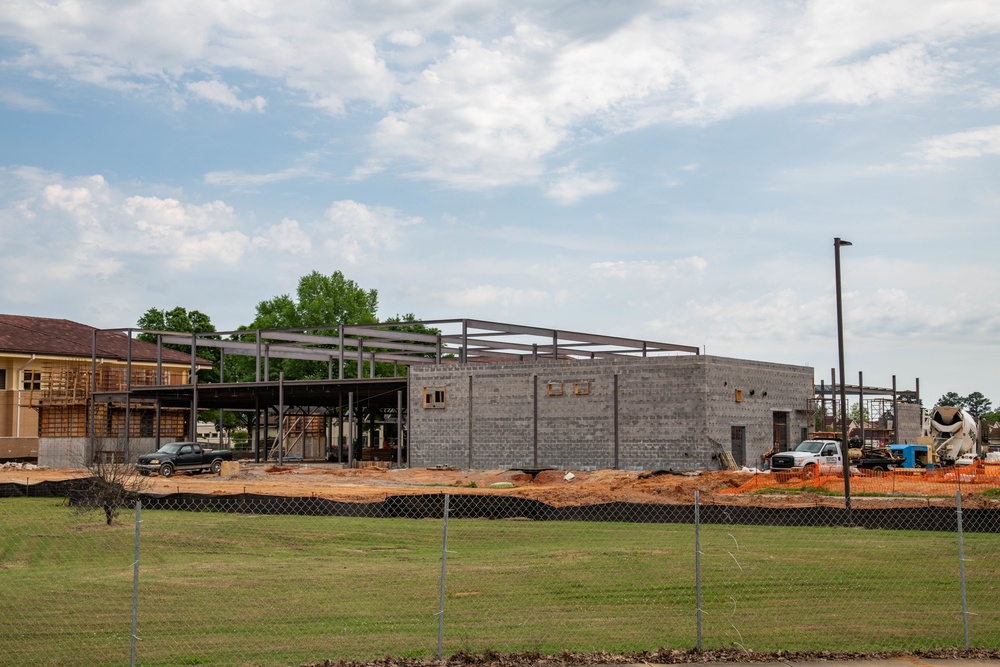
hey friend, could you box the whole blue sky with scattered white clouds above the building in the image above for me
[0,0,1000,405]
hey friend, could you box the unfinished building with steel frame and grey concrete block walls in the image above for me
[0,318,919,469]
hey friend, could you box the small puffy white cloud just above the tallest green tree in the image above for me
[324,199,422,264]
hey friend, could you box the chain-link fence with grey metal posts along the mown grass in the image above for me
[0,486,1000,666]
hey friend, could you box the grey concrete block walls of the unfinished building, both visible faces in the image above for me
[409,355,813,470]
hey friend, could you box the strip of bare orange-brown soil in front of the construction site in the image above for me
[0,462,1000,508]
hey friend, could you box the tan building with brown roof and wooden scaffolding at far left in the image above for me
[0,314,208,467]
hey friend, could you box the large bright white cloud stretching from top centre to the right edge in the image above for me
[376,2,1000,189]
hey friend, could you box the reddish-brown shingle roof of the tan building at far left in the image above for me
[0,314,205,364]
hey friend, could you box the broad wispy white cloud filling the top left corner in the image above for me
[0,0,391,112]
